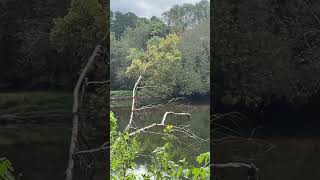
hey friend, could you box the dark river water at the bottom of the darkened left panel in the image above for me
[0,126,108,180]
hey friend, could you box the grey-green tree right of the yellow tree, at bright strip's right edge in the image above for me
[180,22,210,95]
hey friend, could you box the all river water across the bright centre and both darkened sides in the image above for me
[0,104,320,180]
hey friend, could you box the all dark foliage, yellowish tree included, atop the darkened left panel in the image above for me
[0,0,109,90]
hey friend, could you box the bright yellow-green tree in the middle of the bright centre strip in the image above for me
[126,34,182,95]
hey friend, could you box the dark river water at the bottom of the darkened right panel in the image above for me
[213,137,320,180]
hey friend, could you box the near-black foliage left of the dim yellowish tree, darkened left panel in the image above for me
[0,0,71,90]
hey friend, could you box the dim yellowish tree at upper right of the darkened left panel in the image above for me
[50,0,109,57]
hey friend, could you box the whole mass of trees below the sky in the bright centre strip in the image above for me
[111,0,210,95]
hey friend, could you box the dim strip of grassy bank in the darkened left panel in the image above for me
[0,91,73,113]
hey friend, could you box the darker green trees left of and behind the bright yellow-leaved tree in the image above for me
[111,14,169,88]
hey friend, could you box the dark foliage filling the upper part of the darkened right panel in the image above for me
[211,0,320,107]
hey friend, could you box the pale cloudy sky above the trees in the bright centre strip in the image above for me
[110,0,208,18]
